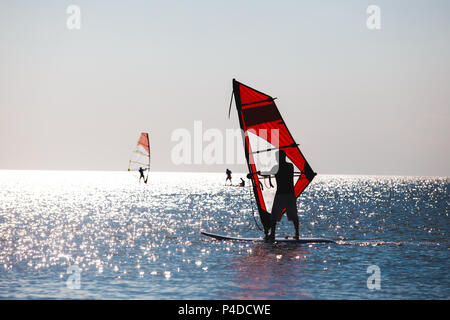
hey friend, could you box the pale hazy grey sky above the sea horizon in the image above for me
[0,0,450,176]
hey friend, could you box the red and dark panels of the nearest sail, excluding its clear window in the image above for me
[233,79,316,232]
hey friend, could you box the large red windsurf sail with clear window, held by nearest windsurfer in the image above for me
[233,79,316,229]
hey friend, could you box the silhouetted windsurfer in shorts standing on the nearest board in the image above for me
[262,150,299,241]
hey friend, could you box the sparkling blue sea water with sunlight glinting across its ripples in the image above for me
[0,171,450,299]
